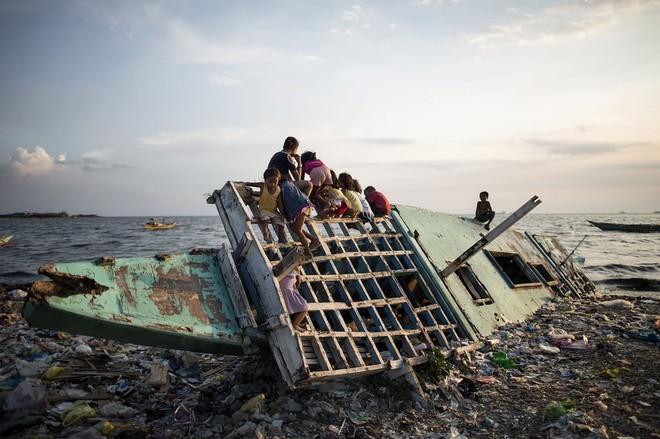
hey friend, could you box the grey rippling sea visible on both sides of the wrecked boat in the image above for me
[0,213,660,295]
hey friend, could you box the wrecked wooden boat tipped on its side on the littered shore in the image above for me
[24,182,595,387]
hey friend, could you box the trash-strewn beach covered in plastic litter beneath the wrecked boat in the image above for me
[0,285,660,439]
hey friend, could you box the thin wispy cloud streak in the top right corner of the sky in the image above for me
[468,0,660,48]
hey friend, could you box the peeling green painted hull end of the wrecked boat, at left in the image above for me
[23,250,258,354]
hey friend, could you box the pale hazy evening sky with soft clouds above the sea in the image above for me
[0,0,660,216]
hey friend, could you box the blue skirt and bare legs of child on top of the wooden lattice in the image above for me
[278,180,321,256]
